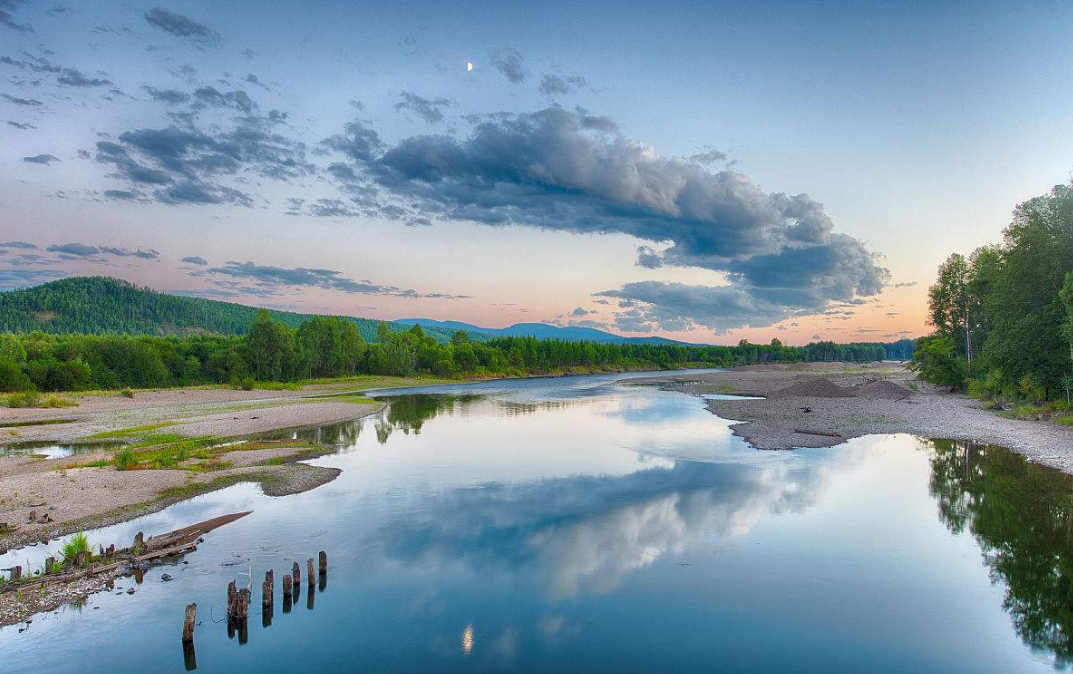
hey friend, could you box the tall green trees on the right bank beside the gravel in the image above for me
[913,180,1073,402]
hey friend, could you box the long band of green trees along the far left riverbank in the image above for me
[0,309,905,391]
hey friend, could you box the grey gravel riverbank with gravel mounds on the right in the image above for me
[629,363,1073,473]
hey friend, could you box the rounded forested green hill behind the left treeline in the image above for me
[0,276,474,342]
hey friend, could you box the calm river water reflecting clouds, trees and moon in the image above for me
[0,377,1073,673]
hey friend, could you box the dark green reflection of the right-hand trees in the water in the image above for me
[928,440,1073,666]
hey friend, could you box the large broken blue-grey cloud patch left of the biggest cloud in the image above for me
[94,109,317,206]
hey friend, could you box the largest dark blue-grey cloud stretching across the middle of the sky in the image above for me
[317,107,888,329]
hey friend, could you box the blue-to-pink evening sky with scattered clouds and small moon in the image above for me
[0,0,1073,343]
